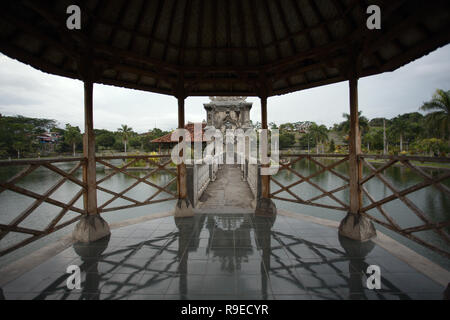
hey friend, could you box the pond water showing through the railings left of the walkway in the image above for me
[0,160,177,267]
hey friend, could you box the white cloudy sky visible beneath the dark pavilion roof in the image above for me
[0,45,450,133]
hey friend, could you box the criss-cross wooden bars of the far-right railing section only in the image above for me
[359,155,450,257]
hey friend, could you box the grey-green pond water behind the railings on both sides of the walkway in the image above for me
[0,159,450,270]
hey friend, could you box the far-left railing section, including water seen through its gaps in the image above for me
[0,157,86,256]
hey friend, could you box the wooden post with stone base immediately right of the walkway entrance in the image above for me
[255,95,277,216]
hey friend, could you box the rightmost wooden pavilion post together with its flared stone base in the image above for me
[339,68,376,241]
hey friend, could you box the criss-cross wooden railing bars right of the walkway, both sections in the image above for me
[270,154,450,257]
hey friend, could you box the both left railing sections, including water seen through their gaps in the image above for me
[0,155,177,256]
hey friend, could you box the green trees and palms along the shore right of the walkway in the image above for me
[271,89,450,156]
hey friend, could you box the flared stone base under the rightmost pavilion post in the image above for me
[339,212,377,241]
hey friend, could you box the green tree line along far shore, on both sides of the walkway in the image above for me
[0,89,450,158]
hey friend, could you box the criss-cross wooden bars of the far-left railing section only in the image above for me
[0,158,86,256]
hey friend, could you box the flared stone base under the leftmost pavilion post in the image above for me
[72,214,111,243]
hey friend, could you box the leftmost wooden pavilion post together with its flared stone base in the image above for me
[73,59,111,243]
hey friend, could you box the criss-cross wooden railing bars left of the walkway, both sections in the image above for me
[0,155,177,257]
